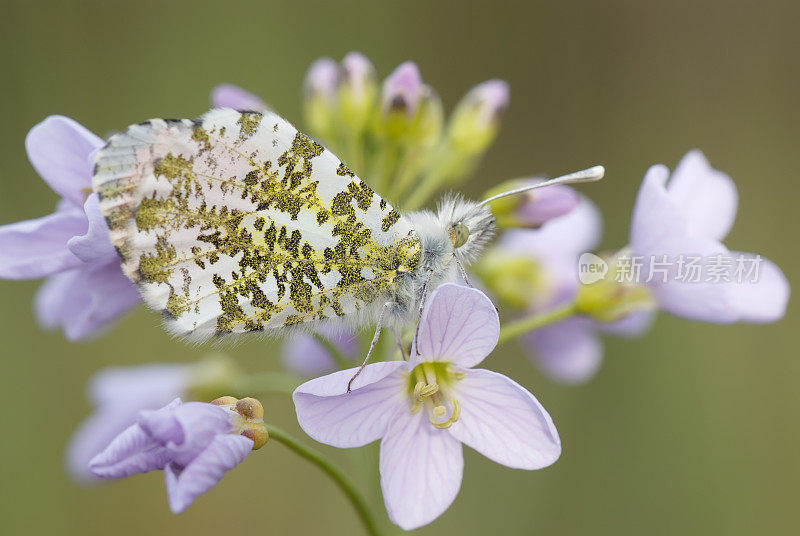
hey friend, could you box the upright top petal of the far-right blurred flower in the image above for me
[667,149,739,240]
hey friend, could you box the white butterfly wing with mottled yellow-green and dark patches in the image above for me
[94,109,420,338]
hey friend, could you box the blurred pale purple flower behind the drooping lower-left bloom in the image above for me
[65,363,194,483]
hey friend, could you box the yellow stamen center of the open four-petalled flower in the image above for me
[408,362,464,429]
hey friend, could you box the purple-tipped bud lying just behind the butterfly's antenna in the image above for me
[485,179,580,229]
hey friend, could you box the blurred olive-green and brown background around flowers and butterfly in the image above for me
[0,0,800,536]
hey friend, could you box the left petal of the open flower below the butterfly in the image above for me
[292,361,408,448]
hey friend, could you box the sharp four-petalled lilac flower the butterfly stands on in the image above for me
[293,284,561,530]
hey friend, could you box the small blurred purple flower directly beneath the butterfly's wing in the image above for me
[281,329,359,377]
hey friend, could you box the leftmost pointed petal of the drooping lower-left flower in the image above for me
[89,424,170,478]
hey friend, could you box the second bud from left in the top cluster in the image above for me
[338,52,378,132]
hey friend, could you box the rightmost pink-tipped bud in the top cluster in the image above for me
[448,80,509,154]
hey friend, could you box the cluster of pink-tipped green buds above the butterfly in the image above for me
[304,52,508,209]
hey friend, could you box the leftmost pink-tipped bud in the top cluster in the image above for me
[303,58,339,140]
